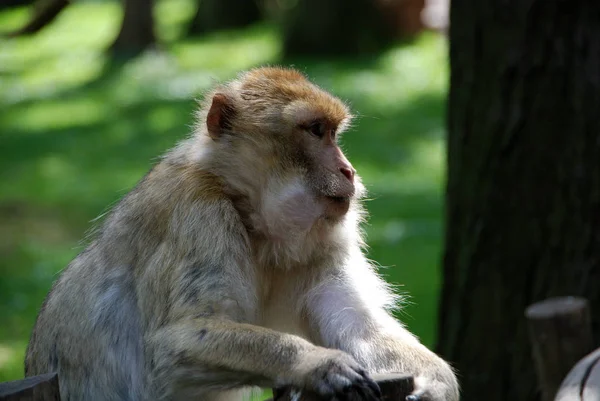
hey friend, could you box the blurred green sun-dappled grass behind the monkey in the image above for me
[0,0,447,381]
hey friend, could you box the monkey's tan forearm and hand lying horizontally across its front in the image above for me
[149,318,378,400]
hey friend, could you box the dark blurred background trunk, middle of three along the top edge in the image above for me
[188,0,261,36]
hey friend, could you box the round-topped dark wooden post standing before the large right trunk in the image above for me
[525,297,593,401]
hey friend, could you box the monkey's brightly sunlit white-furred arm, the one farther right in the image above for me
[307,250,458,401]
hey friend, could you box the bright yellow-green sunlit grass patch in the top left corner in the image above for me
[0,2,120,103]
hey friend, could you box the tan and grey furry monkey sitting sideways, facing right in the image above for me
[25,67,459,401]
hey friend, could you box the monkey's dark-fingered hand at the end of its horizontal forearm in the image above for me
[293,347,381,401]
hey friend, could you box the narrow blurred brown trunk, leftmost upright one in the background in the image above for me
[110,0,156,58]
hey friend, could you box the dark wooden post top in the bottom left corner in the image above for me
[0,373,60,401]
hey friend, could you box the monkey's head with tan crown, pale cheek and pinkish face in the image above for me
[200,68,364,242]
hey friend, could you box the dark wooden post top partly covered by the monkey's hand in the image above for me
[273,373,414,401]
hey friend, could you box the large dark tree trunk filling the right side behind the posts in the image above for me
[438,0,600,401]
